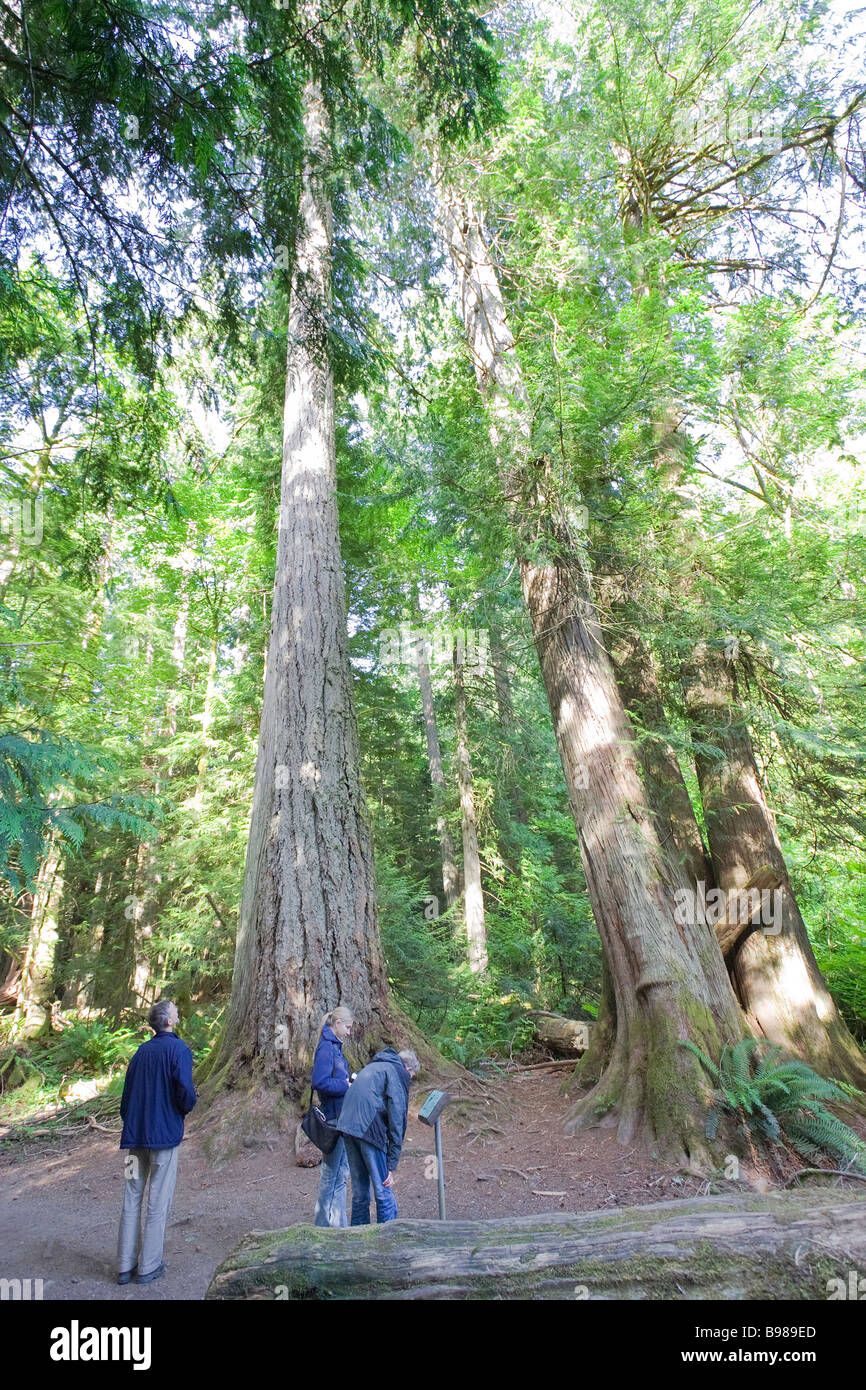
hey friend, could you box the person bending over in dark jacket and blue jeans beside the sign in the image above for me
[336,1047,421,1226]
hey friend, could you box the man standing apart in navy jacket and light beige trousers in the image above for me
[117,999,197,1284]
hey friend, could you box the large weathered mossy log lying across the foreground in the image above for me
[206,1191,866,1301]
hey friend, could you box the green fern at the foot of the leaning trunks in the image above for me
[683,1038,866,1172]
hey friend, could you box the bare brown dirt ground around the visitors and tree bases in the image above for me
[0,1070,856,1302]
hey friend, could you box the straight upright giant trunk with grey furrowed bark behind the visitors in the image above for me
[218,83,386,1090]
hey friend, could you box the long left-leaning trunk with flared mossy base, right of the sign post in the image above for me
[442,184,744,1162]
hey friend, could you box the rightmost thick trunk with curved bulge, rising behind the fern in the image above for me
[685,644,866,1087]
